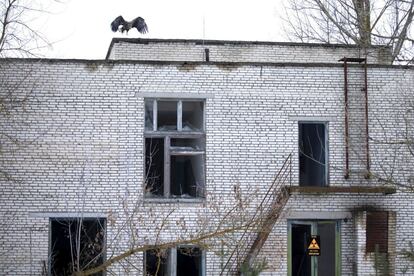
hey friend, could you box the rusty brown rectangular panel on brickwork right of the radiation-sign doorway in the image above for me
[366,212,388,253]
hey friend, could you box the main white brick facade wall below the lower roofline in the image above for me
[0,57,414,275]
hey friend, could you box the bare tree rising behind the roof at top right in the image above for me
[285,0,414,63]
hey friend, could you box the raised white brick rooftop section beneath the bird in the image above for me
[107,39,391,64]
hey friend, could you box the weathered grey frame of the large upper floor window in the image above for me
[143,97,206,202]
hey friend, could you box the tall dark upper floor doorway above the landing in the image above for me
[299,122,328,186]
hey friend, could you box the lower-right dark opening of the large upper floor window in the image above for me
[170,155,204,198]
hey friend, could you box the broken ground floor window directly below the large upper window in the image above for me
[145,246,205,276]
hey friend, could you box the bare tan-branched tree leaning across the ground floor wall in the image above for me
[50,156,291,275]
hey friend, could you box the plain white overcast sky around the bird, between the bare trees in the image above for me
[40,0,283,59]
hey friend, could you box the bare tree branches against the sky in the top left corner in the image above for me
[0,0,56,57]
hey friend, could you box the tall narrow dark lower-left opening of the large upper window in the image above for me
[145,138,164,197]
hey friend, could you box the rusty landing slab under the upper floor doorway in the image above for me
[287,186,397,195]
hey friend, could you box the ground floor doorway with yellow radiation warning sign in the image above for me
[288,220,341,276]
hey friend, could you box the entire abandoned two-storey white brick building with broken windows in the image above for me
[0,38,414,276]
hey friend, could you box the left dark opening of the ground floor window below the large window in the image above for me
[145,250,169,276]
